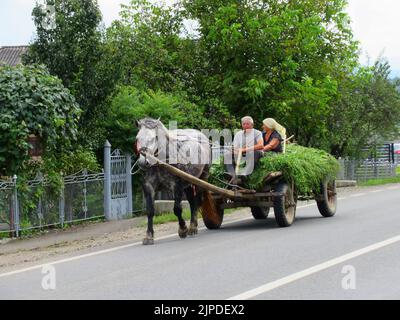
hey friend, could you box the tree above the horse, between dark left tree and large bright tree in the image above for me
[102,0,191,92]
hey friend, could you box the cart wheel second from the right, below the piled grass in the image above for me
[273,182,297,227]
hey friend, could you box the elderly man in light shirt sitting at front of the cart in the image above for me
[226,116,264,184]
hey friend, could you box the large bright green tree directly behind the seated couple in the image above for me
[184,0,357,148]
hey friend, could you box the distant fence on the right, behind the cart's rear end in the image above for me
[337,159,398,181]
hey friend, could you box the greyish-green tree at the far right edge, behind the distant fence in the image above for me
[329,59,400,157]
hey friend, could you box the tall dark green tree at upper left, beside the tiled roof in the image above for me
[24,0,114,144]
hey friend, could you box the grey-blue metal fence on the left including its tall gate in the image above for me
[0,144,143,237]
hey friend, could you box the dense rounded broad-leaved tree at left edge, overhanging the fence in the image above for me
[0,66,81,175]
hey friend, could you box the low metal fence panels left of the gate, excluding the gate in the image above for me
[0,170,104,237]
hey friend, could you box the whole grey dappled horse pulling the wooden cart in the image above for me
[135,118,211,245]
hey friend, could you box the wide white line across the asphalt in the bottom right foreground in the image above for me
[227,235,400,300]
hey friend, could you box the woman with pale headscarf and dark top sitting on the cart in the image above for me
[263,118,286,153]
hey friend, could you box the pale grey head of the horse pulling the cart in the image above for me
[135,118,162,168]
